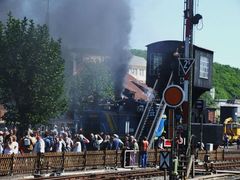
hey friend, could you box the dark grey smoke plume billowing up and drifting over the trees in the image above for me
[0,0,131,98]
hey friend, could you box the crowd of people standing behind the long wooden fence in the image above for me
[0,126,142,154]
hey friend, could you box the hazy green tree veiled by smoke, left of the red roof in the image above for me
[65,58,114,112]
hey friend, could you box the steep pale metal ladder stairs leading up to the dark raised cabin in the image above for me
[135,72,173,143]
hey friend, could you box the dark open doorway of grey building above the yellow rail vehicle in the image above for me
[220,105,238,123]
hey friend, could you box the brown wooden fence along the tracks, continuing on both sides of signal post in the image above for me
[0,149,240,176]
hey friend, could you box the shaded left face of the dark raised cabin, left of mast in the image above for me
[146,41,182,95]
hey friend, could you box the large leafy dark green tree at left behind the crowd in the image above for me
[0,14,66,128]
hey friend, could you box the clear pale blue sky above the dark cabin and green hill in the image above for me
[130,0,240,68]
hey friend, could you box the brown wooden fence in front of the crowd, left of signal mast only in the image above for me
[0,150,163,176]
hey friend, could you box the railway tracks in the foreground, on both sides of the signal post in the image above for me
[9,161,240,180]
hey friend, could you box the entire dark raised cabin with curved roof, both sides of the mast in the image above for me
[146,40,213,102]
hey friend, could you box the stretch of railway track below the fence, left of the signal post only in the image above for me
[25,169,164,180]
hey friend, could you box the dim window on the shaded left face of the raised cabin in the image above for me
[149,53,163,75]
